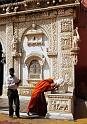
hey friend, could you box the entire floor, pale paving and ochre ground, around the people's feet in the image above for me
[0,96,87,124]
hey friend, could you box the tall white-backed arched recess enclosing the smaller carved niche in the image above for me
[21,24,50,86]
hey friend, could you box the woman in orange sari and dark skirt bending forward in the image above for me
[27,78,55,117]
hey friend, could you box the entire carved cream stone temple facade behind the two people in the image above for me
[0,0,80,119]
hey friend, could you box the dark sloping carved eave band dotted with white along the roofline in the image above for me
[0,0,79,14]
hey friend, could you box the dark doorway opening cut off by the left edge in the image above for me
[0,43,3,96]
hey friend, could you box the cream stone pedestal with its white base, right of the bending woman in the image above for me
[46,93,73,120]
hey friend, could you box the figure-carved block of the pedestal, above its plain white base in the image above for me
[48,94,73,113]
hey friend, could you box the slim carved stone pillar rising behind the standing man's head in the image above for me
[12,23,21,78]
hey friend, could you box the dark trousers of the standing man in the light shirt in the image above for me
[7,89,20,117]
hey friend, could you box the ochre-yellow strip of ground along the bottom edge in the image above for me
[0,114,87,124]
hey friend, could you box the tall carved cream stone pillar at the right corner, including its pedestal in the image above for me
[47,9,78,120]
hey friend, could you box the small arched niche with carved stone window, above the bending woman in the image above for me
[25,53,44,84]
